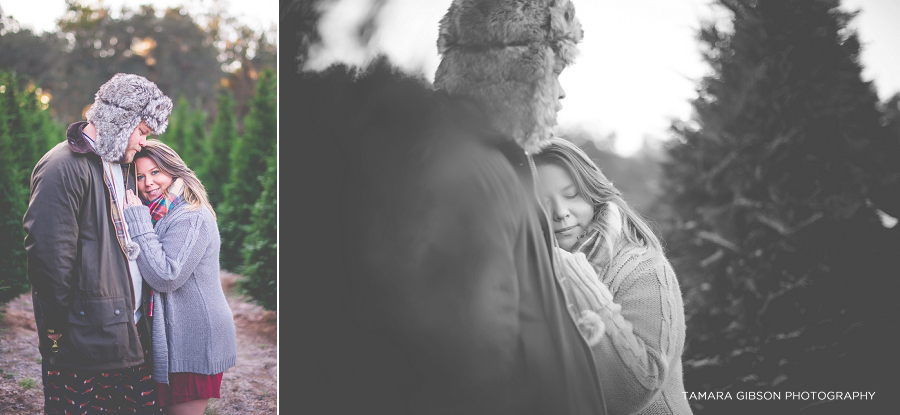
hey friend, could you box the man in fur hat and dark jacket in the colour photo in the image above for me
[23,74,172,414]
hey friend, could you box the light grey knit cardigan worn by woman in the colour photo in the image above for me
[125,199,237,383]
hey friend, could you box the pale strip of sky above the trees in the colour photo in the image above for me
[0,0,278,33]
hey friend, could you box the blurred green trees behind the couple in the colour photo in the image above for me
[0,0,277,310]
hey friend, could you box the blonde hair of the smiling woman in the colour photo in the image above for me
[134,139,216,217]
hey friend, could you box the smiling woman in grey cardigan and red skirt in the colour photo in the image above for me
[124,140,236,415]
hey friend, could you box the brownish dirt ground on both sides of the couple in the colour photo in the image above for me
[0,272,278,415]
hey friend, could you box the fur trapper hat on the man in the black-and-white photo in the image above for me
[434,0,584,152]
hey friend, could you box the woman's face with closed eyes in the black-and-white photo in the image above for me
[537,164,594,251]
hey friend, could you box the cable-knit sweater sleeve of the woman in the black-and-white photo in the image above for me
[591,257,684,414]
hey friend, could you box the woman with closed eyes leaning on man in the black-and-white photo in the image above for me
[534,138,691,414]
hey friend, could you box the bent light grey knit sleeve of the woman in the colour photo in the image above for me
[125,206,210,293]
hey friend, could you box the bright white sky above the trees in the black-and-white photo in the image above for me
[308,0,900,155]
